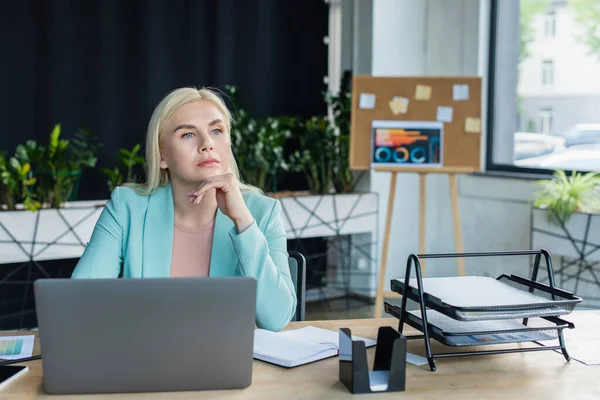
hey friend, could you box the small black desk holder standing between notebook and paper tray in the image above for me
[339,326,406,394]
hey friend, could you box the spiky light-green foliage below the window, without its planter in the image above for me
[533,170,600,225]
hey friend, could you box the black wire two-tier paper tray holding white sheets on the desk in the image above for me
[385,250,581,371]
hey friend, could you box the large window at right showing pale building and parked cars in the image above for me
[486,0,600,174]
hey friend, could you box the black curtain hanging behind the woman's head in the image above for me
[0,0,328,200]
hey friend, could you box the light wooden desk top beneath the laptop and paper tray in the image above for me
[0,311,600,400]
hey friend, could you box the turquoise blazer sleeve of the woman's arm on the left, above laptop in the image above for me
[71,187,123,279]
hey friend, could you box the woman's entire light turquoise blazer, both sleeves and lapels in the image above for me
[72,184,297,331]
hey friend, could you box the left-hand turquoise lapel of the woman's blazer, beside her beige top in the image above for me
[142,184,175,278]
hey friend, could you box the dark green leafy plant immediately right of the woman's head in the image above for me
[225,86,295,192]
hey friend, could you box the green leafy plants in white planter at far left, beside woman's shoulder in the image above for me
[0,125,101,263]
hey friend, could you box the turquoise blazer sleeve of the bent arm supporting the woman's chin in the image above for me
[229,201,297,331]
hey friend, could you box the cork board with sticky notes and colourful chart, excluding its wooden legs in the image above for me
[350,75,482,172]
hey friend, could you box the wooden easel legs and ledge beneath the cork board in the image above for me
[375,167,473,318]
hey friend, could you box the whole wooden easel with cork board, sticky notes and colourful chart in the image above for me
[350,76,482,317]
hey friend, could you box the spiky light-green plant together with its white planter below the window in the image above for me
[531,170,600,265]
